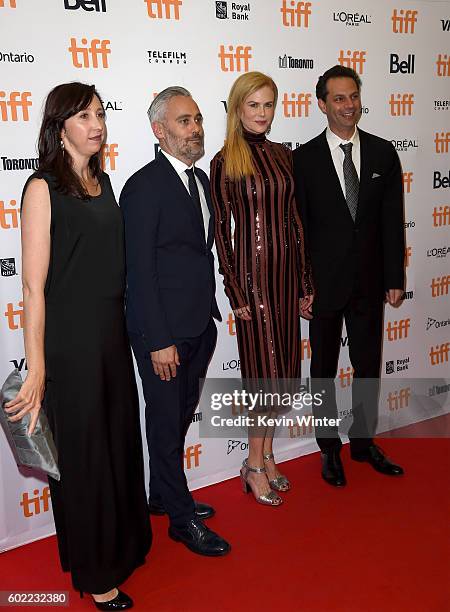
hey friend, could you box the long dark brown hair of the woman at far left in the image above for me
[38,82,103,200]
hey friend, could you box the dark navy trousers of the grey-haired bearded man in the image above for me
[130,318,217,525]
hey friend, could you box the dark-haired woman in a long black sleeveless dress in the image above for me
[4,83,151,610]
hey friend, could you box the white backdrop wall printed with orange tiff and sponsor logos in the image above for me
[0,0,450,550]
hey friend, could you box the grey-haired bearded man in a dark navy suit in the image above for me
[120,87,230,556]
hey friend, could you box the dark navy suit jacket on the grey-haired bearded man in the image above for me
[120,152,220,351]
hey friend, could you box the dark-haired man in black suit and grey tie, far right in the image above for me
[294,66,405,486]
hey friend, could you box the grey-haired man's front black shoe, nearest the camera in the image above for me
[169,518,231,557]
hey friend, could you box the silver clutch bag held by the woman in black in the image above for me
[0,368,61,480]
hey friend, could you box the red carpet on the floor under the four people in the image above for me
[0,419,450,612]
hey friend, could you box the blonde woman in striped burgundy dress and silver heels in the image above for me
[211,72,313,506]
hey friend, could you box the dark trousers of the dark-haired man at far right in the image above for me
[309,298,383,453]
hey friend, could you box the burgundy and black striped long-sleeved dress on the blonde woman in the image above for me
[211,132,313,379]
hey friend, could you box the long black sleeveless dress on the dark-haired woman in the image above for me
[25,173,151,593]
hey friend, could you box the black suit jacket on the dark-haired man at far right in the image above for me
[293,130,405,312]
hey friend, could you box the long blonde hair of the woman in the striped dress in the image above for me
[222,72,278,180]
